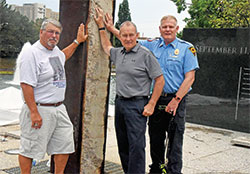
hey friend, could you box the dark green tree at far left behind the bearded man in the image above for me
[0,0,39,58]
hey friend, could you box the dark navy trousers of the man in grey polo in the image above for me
[115,98,148,174]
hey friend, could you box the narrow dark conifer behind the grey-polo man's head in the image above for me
[113,0,131,47]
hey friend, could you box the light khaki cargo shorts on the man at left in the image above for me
[19,104,75,159]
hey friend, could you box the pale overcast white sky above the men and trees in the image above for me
[6,0,190,37]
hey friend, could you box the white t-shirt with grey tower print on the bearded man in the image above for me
[19,40,66,103]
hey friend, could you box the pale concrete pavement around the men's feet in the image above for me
[0,117,250,174]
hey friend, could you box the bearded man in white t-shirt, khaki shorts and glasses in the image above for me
[19,19,87,174]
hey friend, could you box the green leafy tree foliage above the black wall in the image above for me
[171,0,250,28]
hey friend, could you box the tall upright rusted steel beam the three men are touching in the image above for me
[51,0,115,173]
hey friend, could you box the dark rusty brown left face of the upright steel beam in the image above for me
[51,0,89,173]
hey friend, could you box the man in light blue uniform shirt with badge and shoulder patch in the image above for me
[105,14,199,174]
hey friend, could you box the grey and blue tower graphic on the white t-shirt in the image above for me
[49,57,66,88]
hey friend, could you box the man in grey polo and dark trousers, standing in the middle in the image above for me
[95,8,164,174]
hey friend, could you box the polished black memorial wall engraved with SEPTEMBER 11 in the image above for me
[183,28,250,132]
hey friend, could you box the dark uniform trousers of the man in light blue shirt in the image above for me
[149,97,186,174]
